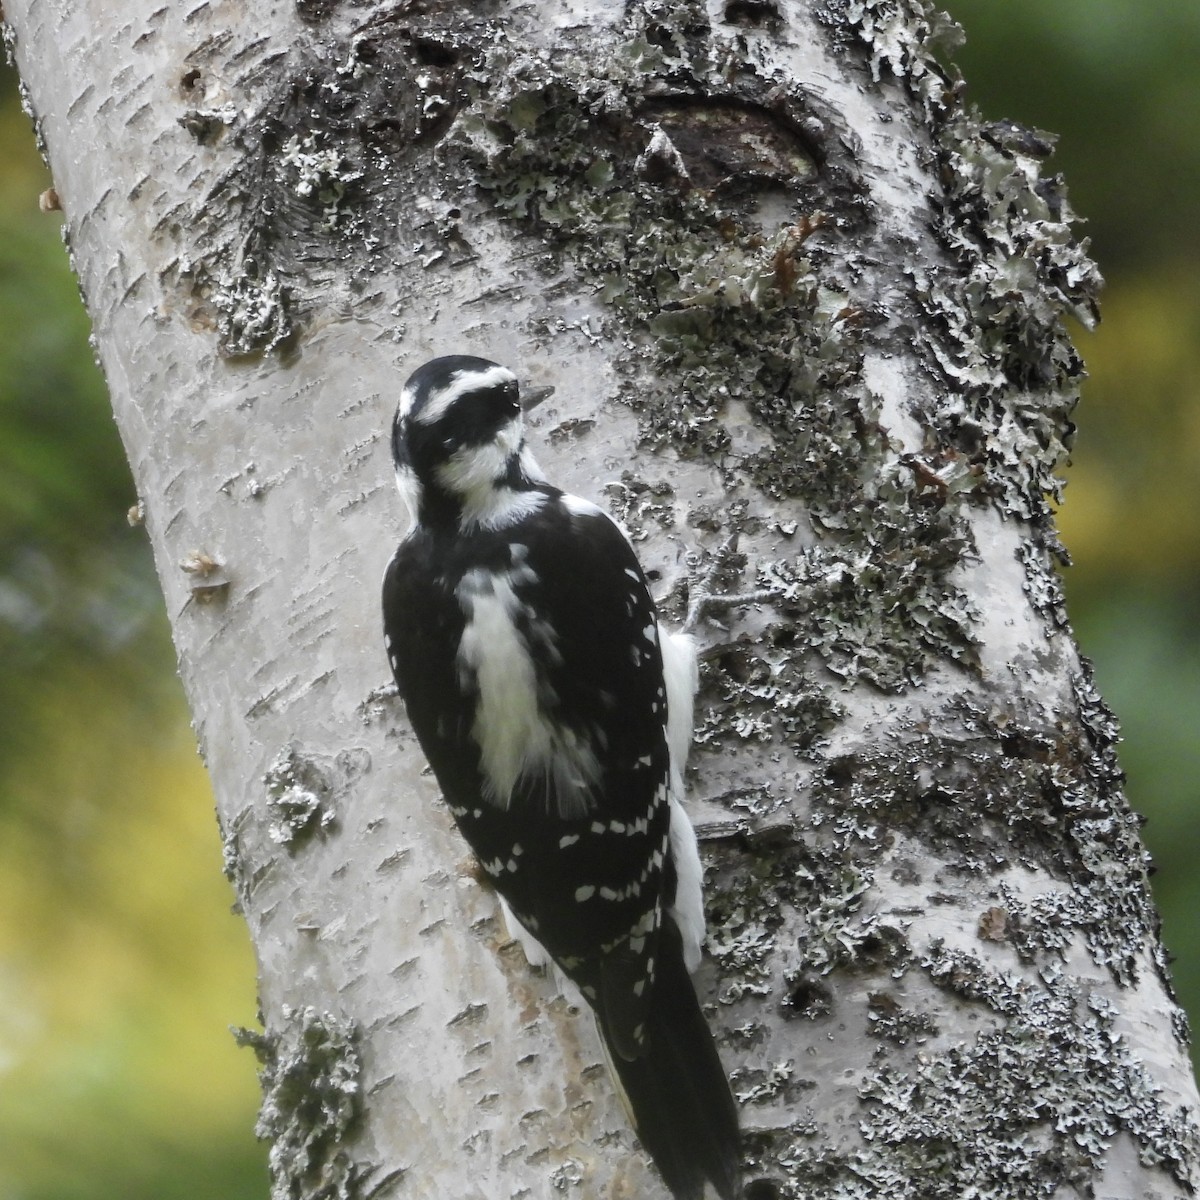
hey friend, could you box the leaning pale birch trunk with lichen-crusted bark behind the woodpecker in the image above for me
[5,0,1198,1200]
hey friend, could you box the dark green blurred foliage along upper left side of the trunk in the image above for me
[0,72,161,777]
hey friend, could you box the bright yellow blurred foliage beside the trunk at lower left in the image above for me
[0,672,258,1195]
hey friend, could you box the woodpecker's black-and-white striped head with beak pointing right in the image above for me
[391,354,548,526]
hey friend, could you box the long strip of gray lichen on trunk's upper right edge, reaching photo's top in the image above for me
[823,0,1102,524]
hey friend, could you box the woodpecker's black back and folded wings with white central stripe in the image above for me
[384,493,673,1055]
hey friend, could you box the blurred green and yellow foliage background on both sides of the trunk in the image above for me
[0,0,1200,1200]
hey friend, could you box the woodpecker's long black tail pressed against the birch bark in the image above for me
[596,914,742,1200]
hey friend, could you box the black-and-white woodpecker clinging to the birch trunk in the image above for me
[383,355,740,1200]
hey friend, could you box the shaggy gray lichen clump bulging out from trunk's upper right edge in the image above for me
[919,113,1100,522]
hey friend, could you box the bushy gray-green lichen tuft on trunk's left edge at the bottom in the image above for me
[235,1006,364,1200]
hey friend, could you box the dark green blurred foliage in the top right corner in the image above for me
[942,0,1200,277]
